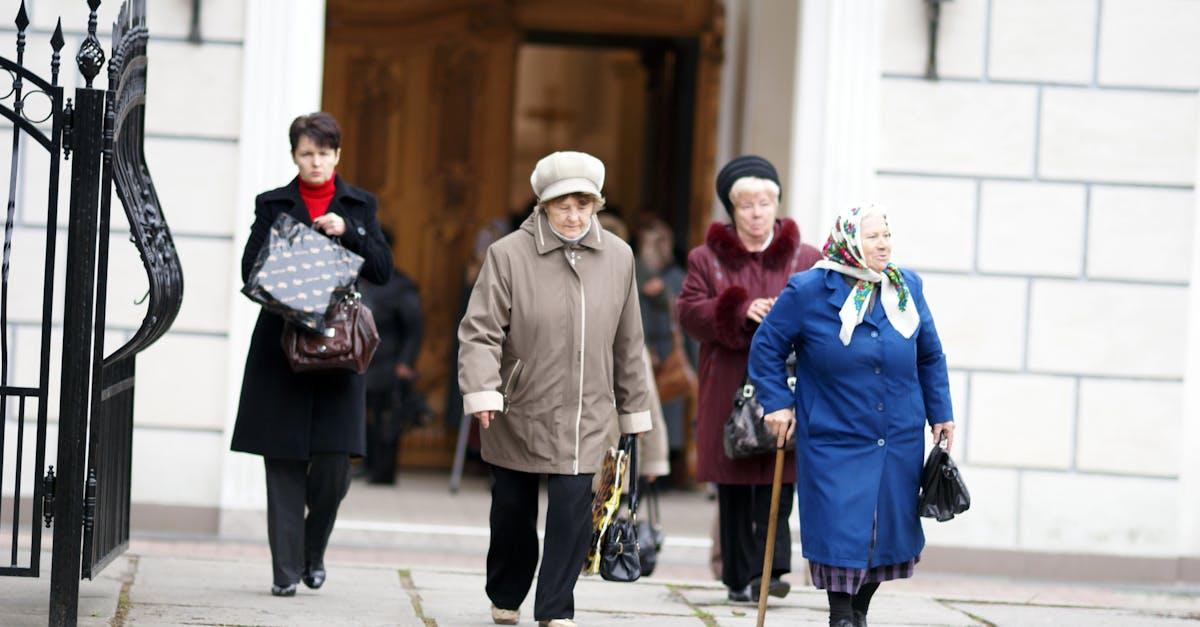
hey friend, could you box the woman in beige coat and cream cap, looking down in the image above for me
[458,153,650,627]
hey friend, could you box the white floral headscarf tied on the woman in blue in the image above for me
[815,203,920,346]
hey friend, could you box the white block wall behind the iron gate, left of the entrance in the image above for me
[0,0,243,516]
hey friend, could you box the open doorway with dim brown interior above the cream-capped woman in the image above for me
[509,31,698,249]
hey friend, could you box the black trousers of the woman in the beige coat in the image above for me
[486,466,592,621]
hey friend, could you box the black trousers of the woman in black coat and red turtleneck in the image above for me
[264,453,350,586]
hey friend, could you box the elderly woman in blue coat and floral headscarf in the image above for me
[749,204,954,627]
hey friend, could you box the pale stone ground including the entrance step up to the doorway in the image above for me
[7,473,1200,627]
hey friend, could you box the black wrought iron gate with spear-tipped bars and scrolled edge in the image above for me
[0,0,184,625]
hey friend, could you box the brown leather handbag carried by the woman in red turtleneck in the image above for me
[282,293,379,375]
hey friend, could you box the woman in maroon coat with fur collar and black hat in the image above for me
[678,155,821,602]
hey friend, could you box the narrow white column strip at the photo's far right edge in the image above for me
[1163,123,1200,557]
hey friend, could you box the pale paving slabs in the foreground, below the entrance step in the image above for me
[0,539,1200,627]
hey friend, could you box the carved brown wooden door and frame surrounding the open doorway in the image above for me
[323,0,722,467]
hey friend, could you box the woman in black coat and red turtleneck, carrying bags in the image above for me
[230,113,392,596]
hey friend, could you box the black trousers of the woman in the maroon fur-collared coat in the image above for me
[716,484,796,590]
